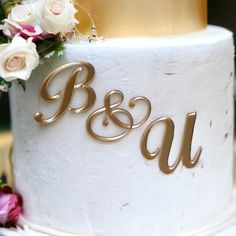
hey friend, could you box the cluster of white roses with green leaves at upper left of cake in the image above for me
[0,0,78,94]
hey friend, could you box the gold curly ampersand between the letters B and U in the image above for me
[86,90,151,142]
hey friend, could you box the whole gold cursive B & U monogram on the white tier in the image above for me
[34,62,202,174]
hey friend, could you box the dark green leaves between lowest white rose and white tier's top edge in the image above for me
[36,39,64,60]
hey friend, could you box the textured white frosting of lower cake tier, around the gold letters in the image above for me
[8,27,234,236]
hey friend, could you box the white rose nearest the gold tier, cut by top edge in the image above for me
[41,0,78,34]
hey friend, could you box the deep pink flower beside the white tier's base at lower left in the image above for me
[0,181,22,228]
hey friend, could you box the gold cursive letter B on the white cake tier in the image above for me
[34,62,96,124]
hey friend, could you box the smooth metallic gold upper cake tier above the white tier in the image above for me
[75,0,207,38]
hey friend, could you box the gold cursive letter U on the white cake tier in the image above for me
[141,113,202,174]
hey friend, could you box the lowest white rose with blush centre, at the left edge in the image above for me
[0,36,39,82]
